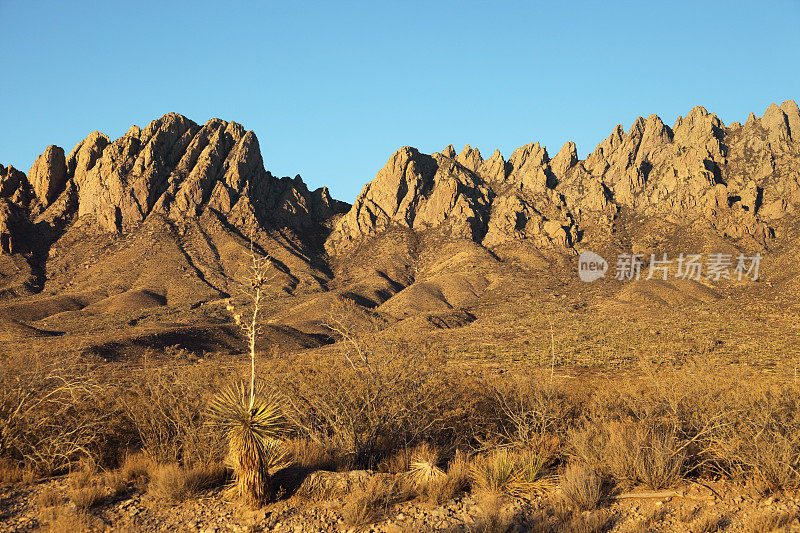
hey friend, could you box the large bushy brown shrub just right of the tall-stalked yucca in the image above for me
[268,330,492,468]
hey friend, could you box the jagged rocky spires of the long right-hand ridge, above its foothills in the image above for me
[327,101,800,253]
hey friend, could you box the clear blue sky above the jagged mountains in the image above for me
[0,0,800,202]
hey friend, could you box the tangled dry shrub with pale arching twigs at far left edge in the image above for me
[0,357,119,474]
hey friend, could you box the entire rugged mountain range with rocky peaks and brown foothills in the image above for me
[0,100,800,356]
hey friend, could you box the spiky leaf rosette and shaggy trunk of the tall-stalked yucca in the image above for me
[209,383,284,505]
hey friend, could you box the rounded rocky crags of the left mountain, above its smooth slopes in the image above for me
[0,113,345,253]
